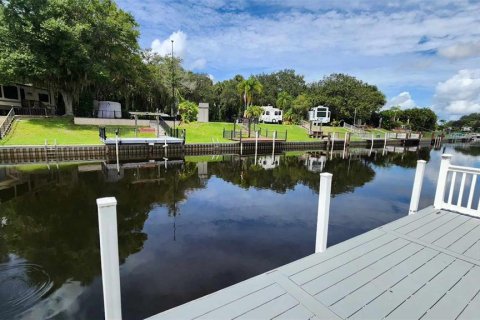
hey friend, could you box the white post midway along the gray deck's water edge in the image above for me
[315,172,332,253]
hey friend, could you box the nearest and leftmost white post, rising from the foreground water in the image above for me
[97,197,122,320]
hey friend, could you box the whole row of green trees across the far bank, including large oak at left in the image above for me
[0,0,436,129]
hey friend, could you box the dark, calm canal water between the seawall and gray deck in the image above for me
[0,145,480,319]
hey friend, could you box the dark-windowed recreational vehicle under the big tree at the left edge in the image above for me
[0,84,55,110]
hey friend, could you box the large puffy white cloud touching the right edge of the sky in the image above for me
[434,69,480,118]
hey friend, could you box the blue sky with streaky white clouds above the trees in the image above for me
[117,0,480,119]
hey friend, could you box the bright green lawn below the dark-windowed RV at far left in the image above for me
[0,117,155,145]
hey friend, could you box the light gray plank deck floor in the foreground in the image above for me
[149,207,480,320]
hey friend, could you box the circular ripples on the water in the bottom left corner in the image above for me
[0,260,53,319]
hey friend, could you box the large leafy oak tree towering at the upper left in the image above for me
[0,0,139,114]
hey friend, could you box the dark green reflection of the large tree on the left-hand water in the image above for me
[0,164,202,288]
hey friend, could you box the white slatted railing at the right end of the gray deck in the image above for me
[433,154,480,217]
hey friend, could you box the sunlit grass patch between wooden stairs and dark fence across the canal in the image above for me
[180,122,233,143]
